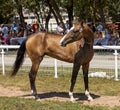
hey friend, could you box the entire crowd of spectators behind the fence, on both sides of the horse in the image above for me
[0,20,120,45]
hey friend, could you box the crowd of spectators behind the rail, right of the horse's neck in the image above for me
[90,23,120,46]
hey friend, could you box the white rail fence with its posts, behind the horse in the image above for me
[0,45,120,80]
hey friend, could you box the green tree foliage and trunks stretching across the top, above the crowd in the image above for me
[0,0,120,28]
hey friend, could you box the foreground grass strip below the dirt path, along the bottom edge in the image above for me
[0,97,111,110]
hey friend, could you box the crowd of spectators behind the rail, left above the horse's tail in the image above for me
[0,22,39,45]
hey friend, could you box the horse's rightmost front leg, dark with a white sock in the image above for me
[82,64,93,101]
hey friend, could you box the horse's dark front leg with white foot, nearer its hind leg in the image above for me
[69,63,80,102]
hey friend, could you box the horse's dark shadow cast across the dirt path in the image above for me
[22,92,100,101]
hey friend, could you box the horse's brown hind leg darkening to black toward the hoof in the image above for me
[29,58,43,100]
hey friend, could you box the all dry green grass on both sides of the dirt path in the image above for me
[0,72,120,110]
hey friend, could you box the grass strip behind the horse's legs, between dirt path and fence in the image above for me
[0,73,120,96]
